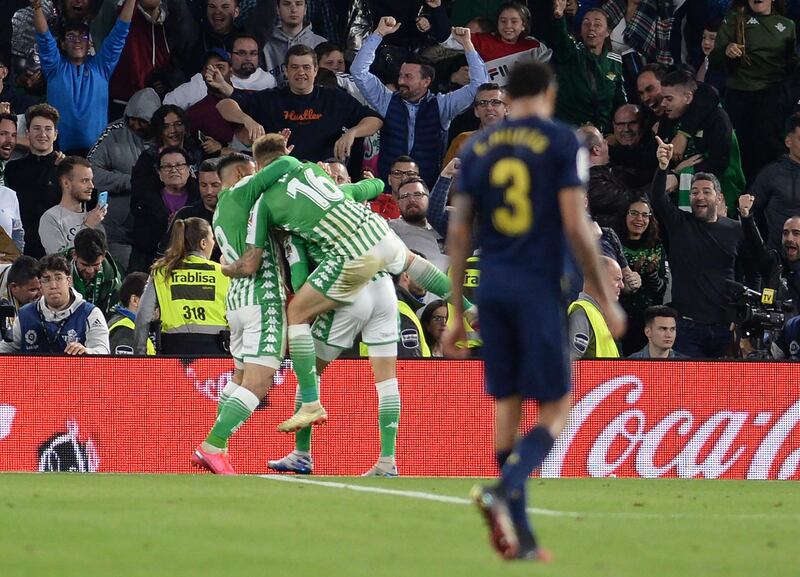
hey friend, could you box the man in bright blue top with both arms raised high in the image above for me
[31,0,136,155]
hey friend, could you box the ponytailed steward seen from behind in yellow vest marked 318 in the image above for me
[135,217,229,355]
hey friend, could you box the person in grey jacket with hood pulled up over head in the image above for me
[87,88,161,271]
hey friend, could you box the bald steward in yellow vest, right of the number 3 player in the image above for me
[568,256,624,360]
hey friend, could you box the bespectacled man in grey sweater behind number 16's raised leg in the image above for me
[389,176,448,272]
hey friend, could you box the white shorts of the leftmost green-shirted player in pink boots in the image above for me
[225,303,286,370]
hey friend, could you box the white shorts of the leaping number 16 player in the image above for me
[307,230,408,304]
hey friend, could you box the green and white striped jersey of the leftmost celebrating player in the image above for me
[212,163,294,310]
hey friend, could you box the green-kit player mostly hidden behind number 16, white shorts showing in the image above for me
[268,172,401,477]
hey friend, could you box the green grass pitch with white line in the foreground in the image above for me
[0,474,800,577]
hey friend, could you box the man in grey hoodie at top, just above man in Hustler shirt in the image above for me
[264,0,326,86]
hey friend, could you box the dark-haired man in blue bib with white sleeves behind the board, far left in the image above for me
[0,254,110,355]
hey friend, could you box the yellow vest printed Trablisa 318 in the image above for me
[153,255,230,334]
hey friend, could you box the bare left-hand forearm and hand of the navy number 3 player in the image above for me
[442,193,475,358]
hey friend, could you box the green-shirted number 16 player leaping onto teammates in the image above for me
[253,134,474,432]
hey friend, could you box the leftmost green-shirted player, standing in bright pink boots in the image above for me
[192,154,286,474]
